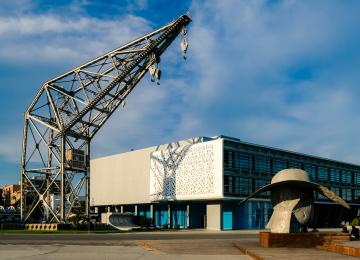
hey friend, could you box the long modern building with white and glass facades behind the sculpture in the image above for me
[90,136,360,230]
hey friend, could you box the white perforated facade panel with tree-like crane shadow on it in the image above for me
[150,143,215,200]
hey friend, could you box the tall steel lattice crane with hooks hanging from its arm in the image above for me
[21,15,191,223]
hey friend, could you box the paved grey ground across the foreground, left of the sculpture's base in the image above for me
[0,230,358,260]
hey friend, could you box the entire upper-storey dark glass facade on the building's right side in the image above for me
[224,140,360,203]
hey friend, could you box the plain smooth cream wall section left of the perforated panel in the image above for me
[90,147,156,206]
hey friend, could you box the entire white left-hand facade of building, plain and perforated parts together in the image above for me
[90,138,224,206]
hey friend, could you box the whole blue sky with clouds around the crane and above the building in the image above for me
[0,0,360,184]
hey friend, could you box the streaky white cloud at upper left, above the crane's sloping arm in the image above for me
[0,14,150,64]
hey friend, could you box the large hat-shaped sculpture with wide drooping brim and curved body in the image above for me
[240,169,350,233]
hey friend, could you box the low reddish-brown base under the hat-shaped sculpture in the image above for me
[259,232,350,248]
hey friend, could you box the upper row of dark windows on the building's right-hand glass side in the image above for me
[224,150,360,185]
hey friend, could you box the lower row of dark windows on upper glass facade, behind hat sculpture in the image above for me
[224,175,360,201]
